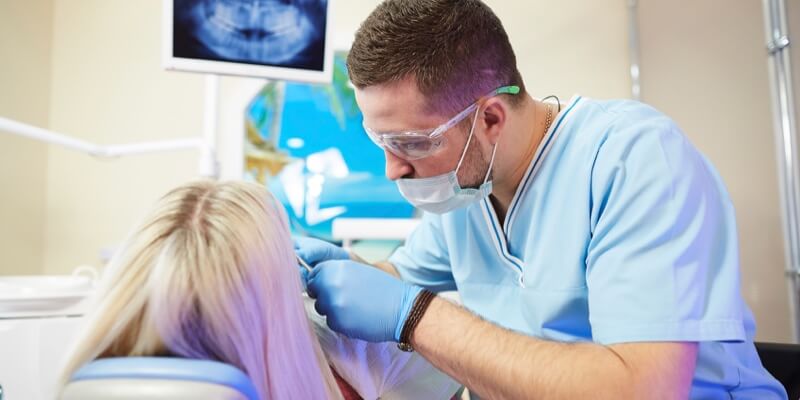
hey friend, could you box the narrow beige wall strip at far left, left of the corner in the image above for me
[0,0,53,275]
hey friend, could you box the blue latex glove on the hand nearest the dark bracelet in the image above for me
[308,260,422,342]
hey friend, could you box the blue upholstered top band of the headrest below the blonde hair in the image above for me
[67,357,259,400]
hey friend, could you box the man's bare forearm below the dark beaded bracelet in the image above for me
[411,297,694,399]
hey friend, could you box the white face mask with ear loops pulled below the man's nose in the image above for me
[397,110,497,214]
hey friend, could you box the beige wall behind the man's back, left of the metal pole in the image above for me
[639,0,797,341]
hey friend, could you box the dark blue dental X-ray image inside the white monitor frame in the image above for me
[171,0,328,71]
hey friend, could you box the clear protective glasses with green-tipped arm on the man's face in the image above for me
[364,85,519,161]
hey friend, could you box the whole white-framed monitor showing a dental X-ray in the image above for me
[163,0,333,82]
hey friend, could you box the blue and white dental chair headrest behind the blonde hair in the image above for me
[60,357,259,400]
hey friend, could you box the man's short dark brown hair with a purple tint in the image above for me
[347,0,525,113]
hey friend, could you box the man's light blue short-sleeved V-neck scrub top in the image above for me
[389,97,787,399]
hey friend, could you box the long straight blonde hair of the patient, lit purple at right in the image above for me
[62,181,341,399]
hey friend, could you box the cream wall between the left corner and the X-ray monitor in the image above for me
[44,0,203,273]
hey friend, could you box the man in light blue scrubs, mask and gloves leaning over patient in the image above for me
[298,0,786,399]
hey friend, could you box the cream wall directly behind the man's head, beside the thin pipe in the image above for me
[334,0,630,100]
